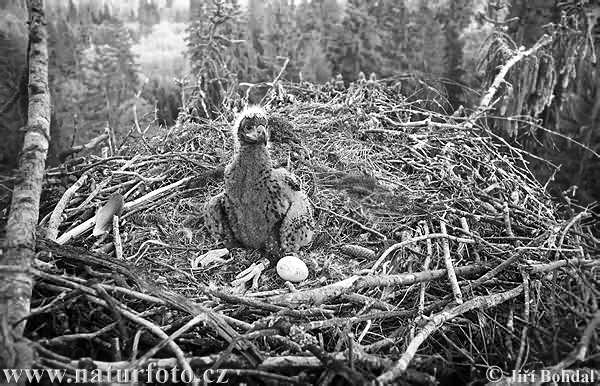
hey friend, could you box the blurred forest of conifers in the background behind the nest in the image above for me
[0,0,600,208]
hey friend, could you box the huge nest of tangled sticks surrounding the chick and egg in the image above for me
[21,82,600,385]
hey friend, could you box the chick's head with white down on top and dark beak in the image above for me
[233,106,269,146]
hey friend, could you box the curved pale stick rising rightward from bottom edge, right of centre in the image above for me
[377,284,523,384]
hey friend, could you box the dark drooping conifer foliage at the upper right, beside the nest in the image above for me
[484,0,600,203]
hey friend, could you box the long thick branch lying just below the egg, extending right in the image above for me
[268,264,488,306]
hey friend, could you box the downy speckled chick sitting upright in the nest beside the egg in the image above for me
[204,106,315,285]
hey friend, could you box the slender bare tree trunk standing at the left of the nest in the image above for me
[0,0,50,376]
